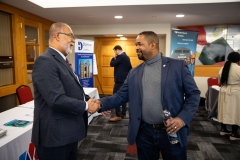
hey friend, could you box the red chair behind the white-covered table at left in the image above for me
[16,85,33,104]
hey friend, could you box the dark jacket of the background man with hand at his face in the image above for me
[110,52,132,83]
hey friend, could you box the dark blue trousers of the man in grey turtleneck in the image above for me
[136,123,187,160]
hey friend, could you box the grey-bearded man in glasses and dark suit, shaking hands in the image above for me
[32,22,98,160]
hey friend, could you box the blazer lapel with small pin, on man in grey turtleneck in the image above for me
[161,56,170,107]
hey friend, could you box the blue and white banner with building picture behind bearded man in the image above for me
[75,39,94,87]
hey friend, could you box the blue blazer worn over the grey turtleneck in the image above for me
[100,57,200,146]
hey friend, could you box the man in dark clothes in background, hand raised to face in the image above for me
[109,45,132,122]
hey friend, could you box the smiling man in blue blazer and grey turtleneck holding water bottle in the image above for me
[94,31,200,160]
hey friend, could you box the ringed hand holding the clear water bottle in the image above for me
[166,117,184,133]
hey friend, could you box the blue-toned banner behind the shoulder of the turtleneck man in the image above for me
[170,29,198,76]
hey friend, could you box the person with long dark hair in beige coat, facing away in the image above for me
[217,52,240,140]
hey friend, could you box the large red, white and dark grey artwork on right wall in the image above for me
[179,25,240,65]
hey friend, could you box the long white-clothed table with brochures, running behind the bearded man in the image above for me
[0,88,100,160]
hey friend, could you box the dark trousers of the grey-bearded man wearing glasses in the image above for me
[36,142,78,160]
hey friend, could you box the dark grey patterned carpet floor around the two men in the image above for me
[78,107,240,160]
